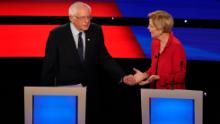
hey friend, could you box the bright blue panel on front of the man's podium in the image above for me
[33,95,77,124]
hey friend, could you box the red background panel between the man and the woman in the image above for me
[102,26,145,58]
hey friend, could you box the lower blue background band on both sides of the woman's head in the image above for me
[132,26,220,61]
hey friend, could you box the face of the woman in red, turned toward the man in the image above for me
[147,19,162,38]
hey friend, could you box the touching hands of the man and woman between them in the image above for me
[123,68,160,86]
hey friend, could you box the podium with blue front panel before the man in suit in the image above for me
[24,87,86,124]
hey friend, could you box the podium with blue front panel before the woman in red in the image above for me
[141,89,203,124]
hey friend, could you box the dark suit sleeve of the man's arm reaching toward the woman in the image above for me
[98,27,125,82]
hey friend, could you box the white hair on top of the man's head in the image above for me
[69,1,92,15]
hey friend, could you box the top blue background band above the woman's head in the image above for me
[116,0,220,20]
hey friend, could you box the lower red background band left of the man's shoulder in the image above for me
[0,25,56,57]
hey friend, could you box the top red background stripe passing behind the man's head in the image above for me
[0,0,121,17]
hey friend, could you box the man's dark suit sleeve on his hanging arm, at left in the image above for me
[41,32,57,85]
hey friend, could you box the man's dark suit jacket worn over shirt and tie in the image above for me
[42,23,124,124]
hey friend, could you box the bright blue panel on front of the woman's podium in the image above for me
[150,98,194,124]
